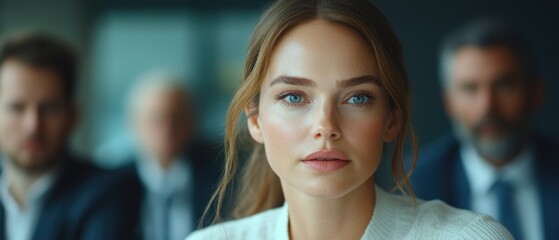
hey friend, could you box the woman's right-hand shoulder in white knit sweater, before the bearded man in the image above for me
[370,188,514,240]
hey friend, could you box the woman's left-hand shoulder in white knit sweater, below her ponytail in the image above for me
[186,207,282,240]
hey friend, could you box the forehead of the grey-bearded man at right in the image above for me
[450,46,522,81]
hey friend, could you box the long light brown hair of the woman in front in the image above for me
[206,0,417,225]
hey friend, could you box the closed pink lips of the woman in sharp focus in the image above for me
[302,150,351,172]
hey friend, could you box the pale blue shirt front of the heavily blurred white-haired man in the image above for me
[137,158,194,240]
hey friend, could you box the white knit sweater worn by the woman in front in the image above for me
[187,187,514,240]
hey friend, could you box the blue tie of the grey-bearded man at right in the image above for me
[493,178,522,240]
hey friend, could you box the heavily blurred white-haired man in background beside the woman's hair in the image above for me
[118,73,218,240]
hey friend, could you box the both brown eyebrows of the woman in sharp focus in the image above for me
[270,75,380,88]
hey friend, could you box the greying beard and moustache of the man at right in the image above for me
[453,115,528,163]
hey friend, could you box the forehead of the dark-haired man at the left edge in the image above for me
[0,60,64,99]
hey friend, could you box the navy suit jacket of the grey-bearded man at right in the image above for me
[412,135,559,239]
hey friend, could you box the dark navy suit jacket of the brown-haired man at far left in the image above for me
[0,157,137,240]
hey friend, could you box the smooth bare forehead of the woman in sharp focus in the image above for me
[266,19,378,82]
